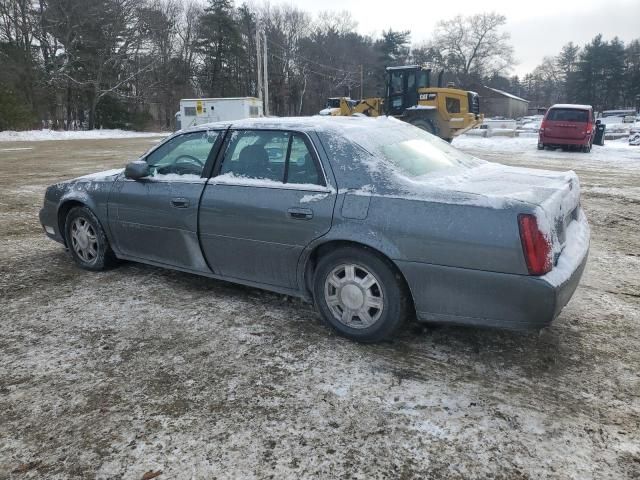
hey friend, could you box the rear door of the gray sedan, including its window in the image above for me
[200,130,336,288]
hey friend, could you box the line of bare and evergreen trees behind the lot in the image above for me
[0,0,640,130]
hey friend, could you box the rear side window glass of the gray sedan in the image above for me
[220,130,324,185]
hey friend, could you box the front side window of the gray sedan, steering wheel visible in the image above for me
[146,131,220,179]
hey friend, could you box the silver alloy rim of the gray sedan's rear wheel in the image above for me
[324,263,384,329]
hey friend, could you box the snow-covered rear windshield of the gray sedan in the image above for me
[353,124,483,178]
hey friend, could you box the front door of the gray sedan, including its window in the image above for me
[109,130,223,272]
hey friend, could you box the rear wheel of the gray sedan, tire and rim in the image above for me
[313,247,410,343]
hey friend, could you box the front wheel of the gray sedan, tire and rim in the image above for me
[64,207,116,271]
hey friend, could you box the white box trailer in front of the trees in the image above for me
[176,97,264,130]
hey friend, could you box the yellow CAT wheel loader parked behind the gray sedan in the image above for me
[320,65,484,142]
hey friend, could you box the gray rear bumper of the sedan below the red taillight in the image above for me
[396,251,588,330]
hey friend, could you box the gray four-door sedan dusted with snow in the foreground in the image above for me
[40,117,589,342]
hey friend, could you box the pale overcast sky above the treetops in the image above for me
[270,0,640,75]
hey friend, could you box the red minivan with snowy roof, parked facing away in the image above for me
[538,104,595,152]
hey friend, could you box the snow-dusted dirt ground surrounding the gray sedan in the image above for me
[0,138,640,479]
